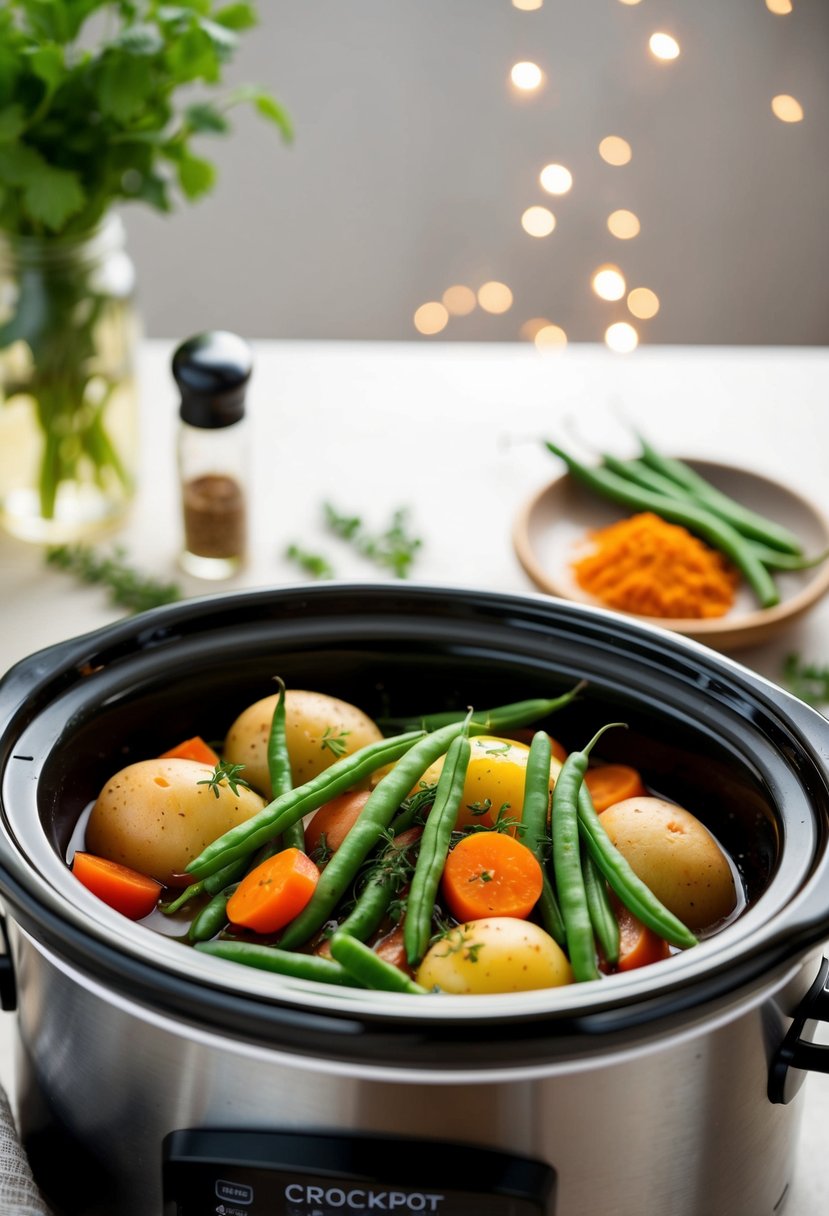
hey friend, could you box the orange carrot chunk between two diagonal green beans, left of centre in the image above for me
[227,849,320,933]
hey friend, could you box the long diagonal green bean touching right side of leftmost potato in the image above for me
[187,731,424,878]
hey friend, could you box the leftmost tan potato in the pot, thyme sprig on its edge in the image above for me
[86,759,264,885]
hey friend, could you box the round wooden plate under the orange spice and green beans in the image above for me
[513,460,829,651]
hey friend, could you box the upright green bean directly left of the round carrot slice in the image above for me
[404,734,472,967]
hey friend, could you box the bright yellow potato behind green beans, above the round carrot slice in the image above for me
[418,734,562,828]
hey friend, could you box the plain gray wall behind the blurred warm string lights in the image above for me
[125,0,829,344]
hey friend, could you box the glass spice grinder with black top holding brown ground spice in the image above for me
[173,331,253,579]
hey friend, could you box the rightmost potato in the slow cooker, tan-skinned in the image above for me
[593,796,737,929]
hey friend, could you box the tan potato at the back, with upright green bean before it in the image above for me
[222,688,383,799]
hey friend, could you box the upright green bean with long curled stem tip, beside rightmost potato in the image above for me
[553,722,622,981]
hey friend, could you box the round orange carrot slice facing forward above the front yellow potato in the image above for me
[441,832,543,922]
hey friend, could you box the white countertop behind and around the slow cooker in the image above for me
[0,340,829,1216]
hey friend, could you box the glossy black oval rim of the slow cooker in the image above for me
[0,582,829,1058]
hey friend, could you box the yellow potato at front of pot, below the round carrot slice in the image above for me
[416,916,573,995]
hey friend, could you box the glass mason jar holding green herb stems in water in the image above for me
[0,215,139,544]
